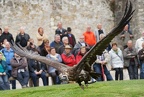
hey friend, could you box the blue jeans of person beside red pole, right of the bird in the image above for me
[93,63,113,81]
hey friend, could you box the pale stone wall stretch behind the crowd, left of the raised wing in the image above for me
[0,0,114,41]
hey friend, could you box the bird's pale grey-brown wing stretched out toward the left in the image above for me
[11,43,70,73]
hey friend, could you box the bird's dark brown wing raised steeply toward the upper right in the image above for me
[76,0,134,73]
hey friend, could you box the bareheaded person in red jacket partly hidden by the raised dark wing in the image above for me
[76,46,87,64]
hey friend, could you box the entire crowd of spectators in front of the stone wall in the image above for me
[0,23,144,90]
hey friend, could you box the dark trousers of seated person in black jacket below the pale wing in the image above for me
[30,72,48,87]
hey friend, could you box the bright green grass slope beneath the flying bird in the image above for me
[0,80,144,97]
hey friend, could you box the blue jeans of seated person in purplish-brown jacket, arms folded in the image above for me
[17,71,29,86]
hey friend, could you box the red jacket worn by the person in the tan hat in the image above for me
[61,53,76,67]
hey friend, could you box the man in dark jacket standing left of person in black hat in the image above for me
[55,22,67,39]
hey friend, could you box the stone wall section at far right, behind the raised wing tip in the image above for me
[114,0,144,44]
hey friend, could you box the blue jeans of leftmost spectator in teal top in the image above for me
[0,75,10,90]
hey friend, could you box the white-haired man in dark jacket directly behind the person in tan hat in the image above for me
[58,36,72,55]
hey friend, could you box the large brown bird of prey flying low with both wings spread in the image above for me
[11,0,134,89]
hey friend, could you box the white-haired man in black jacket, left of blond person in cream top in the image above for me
[15,27,30,47]
